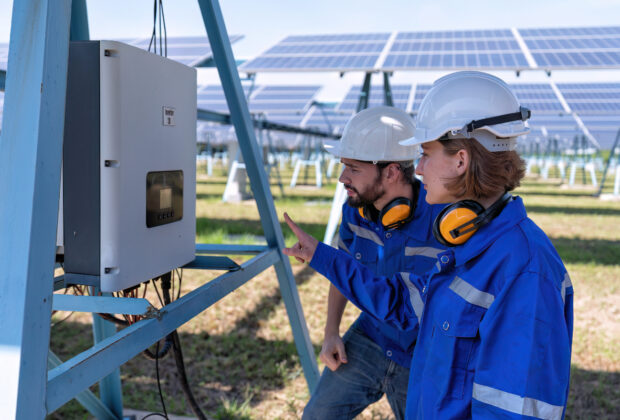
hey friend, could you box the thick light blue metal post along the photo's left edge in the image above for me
[0,0,71,419]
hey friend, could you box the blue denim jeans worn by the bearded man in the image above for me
[302,324,409,420]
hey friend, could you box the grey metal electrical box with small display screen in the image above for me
[58,41,196,292]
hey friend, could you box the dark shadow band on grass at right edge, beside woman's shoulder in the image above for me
[551,237,620,265]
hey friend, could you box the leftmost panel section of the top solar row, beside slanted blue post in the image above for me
[239,33,390,73]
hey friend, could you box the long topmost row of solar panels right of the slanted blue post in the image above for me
[240,26,620,73]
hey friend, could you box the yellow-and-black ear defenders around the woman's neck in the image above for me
[433,192,512,246]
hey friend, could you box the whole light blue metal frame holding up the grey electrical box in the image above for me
[0,0,318,418]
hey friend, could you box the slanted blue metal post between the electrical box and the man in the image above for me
[198,0,319,391]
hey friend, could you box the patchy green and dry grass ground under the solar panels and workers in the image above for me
[49,168,620,420]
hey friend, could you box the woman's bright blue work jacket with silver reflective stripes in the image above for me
[311,197,573,419]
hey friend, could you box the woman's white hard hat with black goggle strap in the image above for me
[401,71,530,152]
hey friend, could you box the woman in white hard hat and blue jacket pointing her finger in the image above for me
[284,72,573,419]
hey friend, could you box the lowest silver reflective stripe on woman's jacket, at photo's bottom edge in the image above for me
[473,382,564,420]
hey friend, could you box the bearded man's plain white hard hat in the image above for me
[323,106,417,162]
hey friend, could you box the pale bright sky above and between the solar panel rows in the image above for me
[0,0,620,96]
